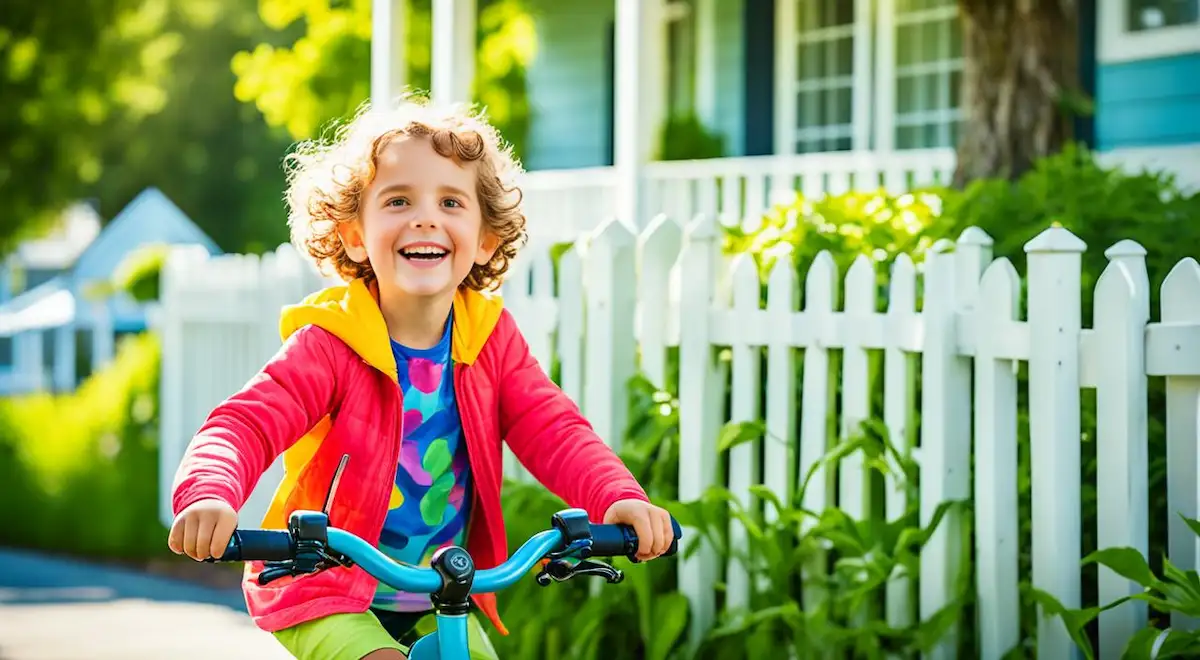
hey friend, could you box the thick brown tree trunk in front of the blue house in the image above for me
[954,0,1081,187]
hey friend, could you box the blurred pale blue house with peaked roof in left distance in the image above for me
[0,188,221,396]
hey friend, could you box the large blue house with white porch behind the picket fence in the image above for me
[372,0,1200,243]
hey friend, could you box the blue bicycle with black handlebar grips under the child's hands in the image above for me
[205,509,683,660]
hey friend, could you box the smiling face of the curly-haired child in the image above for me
[338,138,497,303]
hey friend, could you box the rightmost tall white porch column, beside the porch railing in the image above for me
[613,0,667,228]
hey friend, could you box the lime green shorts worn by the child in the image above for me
[275,610,499,660]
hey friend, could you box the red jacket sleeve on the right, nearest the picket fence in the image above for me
[498,311,649,522]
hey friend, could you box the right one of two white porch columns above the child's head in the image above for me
[430,0,476,103]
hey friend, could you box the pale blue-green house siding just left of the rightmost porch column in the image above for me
[524,0,616,170]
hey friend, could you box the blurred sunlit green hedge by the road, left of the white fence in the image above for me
[0,335,167,559]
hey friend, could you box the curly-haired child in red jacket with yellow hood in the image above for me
[169,96,673,660]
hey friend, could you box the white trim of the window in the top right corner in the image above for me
[1096,0,1200,64]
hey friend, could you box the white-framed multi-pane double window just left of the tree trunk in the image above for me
[775,0,962,154]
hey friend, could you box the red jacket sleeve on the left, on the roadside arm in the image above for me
[172,326,337,515]
